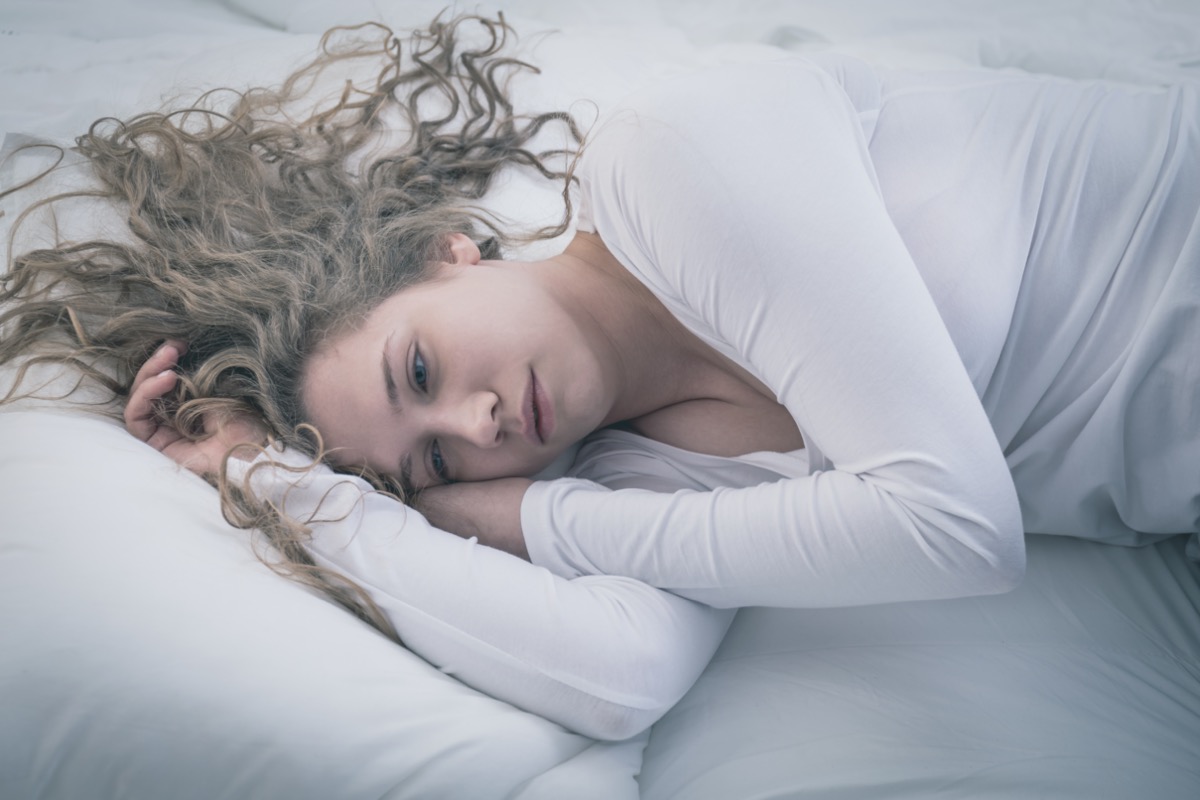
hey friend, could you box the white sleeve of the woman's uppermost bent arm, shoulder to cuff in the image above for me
[522,62,1025,607]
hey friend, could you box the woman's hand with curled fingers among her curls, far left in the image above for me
[125,341,266,475]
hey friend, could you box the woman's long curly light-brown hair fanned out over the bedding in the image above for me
[0,10,582,638]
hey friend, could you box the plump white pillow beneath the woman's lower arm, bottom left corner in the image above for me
[0,410,644,799]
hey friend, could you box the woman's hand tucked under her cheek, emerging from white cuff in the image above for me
[415,477,533,561]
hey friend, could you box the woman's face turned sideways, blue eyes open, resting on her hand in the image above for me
[304,237,612,489]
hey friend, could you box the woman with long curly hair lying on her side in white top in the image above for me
[2,10,1200,727]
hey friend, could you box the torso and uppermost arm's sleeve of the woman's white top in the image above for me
[522,58,1200,606]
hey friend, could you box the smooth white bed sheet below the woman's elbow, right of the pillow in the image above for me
[640,536,1200,800]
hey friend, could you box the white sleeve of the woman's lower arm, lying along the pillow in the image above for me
[229,453,732,739]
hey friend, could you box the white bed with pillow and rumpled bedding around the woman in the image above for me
[0,0,1200,800]
